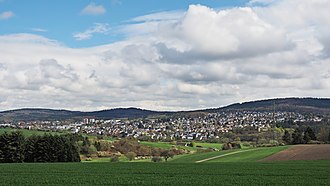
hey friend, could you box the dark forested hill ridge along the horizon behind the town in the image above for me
[0,98,330,123]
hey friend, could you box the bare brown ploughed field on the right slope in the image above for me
[261,144,330,161]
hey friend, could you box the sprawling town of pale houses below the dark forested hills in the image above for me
[0,111,322,140]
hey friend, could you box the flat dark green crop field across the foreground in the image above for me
[0,161,330,185]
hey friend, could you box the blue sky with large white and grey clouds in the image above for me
[0,0,330,111]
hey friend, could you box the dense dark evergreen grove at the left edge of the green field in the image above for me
[0,132,80,163]
